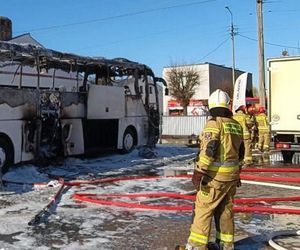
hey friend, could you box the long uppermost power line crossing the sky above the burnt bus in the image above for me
[16,0,217,33]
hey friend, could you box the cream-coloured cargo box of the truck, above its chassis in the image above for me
[268,58,300,134]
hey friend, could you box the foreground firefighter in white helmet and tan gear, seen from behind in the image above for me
[176,89,244,250]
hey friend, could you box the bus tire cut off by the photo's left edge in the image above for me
[0,136,14,174]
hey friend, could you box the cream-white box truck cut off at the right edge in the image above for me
[268,56,300,162]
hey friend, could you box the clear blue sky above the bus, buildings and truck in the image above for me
[0,0,300,84]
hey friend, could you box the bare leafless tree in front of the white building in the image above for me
[167,65,200,115]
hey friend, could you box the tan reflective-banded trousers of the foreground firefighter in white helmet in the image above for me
[188,180,238,250]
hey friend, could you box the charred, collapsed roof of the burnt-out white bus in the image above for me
[0,41,154,76]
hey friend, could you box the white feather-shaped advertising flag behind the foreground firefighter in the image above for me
[232,73,248,113]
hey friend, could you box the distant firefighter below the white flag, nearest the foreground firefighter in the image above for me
[233,105,253,166]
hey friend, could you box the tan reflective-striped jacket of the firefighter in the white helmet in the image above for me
[195,117,244,181]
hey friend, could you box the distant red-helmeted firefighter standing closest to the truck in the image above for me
[256,107,270,162]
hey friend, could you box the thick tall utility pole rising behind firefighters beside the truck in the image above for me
[256,0,266,108]
